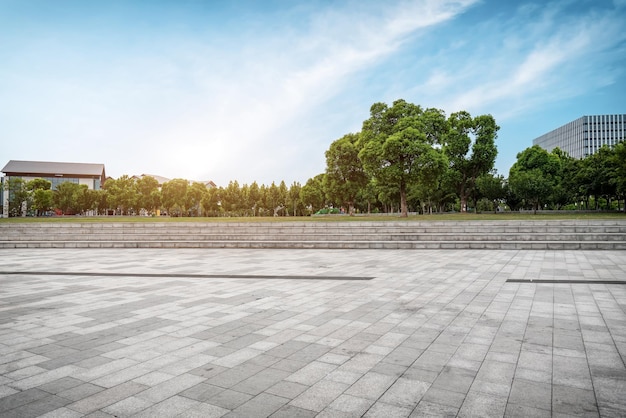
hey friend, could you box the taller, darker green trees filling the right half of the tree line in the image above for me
[302,100,626,216]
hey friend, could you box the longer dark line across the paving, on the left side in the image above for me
[0,271,374,281]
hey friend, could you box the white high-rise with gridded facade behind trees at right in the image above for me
[533,114,626,159]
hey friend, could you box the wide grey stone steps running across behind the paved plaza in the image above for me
[0,218,626,250]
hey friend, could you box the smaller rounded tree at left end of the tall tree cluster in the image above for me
[324,134,369,215]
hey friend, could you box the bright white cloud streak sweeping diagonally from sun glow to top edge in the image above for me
[129,1,473,183]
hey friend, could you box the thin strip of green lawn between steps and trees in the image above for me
[0,211,626,224]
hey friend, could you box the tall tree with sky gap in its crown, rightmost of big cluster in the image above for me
[444,111,500,212]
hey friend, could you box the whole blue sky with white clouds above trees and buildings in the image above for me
[0,0,626,186]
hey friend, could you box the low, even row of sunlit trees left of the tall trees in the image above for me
[6,175,310,216]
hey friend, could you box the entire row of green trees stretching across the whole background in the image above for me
[7,100,626,216]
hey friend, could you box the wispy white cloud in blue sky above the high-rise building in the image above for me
[412,5,626,120]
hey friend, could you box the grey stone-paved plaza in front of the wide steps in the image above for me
[0,249,626,418]
